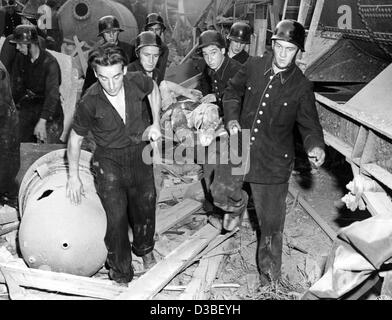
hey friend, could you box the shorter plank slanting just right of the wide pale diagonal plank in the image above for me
[178,238,233,300]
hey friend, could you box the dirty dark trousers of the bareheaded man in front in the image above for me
[93,143,156,282]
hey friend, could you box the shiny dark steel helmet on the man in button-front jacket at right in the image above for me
[271,20,305,51]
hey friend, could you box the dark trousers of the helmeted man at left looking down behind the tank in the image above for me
[19,99,64,143]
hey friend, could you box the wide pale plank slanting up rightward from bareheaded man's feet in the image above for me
[116,224,220,300]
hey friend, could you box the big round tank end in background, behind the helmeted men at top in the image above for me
[58,0,138,45]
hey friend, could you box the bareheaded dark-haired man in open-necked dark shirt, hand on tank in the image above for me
[67,43,161,283]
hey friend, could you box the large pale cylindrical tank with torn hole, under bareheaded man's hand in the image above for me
[18,149,107,276]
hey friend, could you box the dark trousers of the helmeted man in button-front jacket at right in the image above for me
[250,183,288,280]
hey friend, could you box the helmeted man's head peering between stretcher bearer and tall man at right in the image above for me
[227,21,252,64]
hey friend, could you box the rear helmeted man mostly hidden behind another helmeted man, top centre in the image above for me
[129,13,169,82]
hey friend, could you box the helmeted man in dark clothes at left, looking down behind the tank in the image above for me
[10,25,64,143]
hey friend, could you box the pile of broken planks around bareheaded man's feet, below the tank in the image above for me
[0,168,242,300]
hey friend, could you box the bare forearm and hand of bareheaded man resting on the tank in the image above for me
[67,129,84,204]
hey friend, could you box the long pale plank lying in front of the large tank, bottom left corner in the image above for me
[0,263,126,299]
